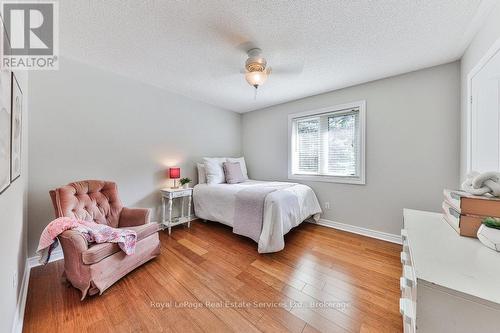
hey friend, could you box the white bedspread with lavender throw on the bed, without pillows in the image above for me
[193,180,321,253]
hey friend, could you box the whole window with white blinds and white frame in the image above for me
[288,101,365,184]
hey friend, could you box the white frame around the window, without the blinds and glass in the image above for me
[288,100,366,185]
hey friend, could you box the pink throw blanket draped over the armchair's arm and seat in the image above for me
[36,217,137,265]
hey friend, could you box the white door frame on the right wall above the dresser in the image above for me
[466,38,500,174]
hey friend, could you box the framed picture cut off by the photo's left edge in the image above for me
[0,17,12,193]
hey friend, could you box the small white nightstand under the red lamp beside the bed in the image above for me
[160,188,196,235]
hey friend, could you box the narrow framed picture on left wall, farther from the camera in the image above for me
[10,73,23,182]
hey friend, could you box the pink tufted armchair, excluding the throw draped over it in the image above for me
[49,180,160,300]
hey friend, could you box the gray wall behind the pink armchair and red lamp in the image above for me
[29,58,241,255]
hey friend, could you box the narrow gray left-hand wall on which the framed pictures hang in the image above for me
[0,71,28,332]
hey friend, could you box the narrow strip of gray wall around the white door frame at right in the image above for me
[460,4,500,180]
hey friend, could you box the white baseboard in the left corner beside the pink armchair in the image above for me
[12,247,64,333]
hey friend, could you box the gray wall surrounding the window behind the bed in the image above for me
[243,62,460,234]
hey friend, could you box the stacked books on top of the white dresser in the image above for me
[443,190,500,238]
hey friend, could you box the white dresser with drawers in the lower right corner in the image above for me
[400,209,500,333]
